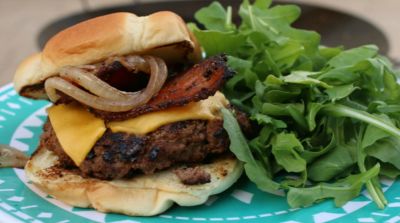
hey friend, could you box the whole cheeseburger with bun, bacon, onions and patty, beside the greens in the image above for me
[14,11,249,216]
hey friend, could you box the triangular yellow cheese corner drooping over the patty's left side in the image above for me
[47,104,106,166]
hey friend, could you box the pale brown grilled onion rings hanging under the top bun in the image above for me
[45,56,167,112]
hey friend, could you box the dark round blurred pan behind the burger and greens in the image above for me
[37,0,389,54]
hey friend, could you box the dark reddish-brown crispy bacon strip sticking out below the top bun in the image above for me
[92,55,233,121]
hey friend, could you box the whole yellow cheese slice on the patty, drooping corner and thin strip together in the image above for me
[47,92,229,166]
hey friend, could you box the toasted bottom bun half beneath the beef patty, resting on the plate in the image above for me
[25,145,242,216]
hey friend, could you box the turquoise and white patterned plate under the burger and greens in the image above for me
[0,85,400,223]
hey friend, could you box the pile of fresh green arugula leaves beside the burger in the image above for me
[189,0,400,208]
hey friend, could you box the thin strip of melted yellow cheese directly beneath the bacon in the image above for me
[108,92,228,135]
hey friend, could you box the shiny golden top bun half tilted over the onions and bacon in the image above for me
[14,11,201,98]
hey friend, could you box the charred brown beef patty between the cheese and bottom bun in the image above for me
[40,112,250,180]
